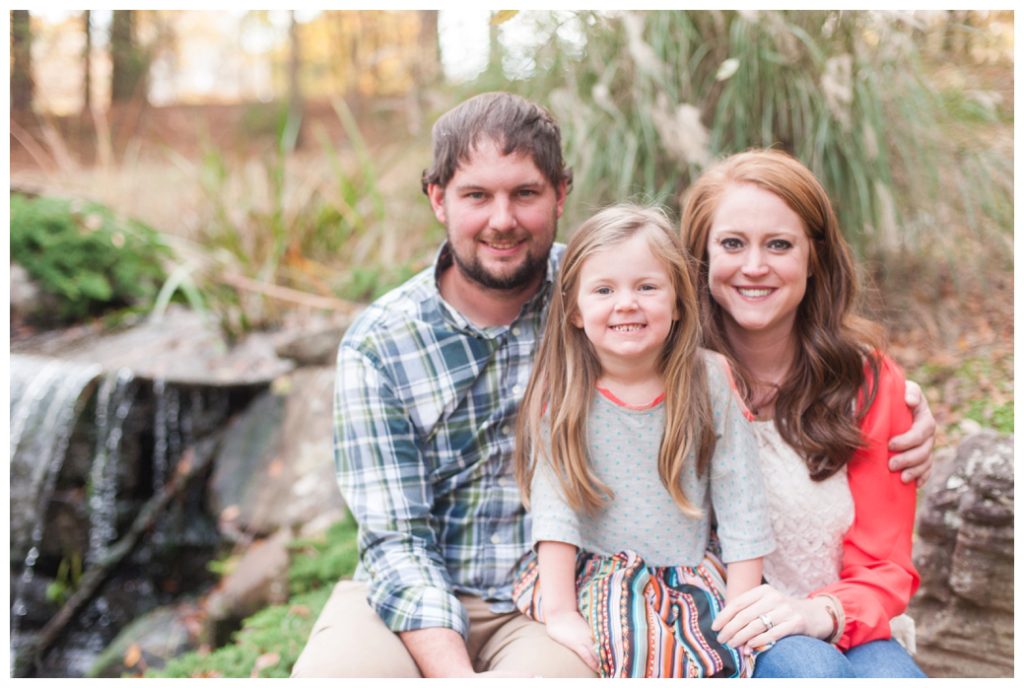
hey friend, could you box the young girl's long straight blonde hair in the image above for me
[515,204,715,517]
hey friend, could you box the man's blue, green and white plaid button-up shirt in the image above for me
[334,245,564,638]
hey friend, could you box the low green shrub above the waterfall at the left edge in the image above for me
[10,194,171,320]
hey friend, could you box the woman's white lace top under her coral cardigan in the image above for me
[752,421,853,597]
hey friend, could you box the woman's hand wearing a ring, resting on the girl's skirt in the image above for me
[711,585,833,652]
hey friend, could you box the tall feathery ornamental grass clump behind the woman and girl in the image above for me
[520,11,1013,272]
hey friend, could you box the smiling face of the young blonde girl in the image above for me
[571,232,679,371]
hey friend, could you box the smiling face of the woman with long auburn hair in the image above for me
[708,183,811,336]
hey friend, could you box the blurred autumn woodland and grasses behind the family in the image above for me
[9,9,1015,679]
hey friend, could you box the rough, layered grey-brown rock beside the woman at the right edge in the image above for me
[910,430,1014,678]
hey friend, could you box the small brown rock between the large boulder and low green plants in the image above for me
[204,530,292,646]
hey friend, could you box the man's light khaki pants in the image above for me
[292,581,595,678]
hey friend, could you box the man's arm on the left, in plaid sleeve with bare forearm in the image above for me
[334,344,471,676]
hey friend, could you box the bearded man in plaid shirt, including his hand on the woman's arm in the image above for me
[293,93,934,677]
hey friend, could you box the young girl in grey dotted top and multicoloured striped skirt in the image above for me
[513,205,774,677]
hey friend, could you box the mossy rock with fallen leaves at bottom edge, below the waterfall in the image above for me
[87,601,203,678]
